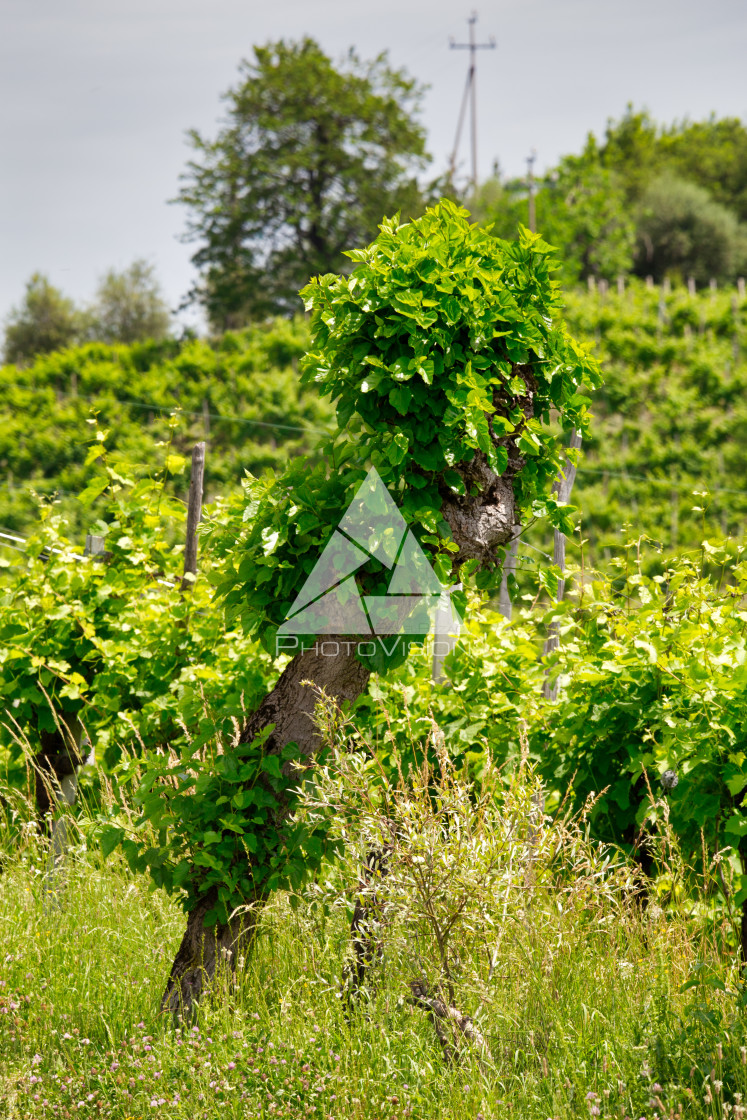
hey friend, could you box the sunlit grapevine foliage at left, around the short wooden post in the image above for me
[0,430,274,801]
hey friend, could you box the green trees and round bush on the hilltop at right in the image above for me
[470,105,747,286]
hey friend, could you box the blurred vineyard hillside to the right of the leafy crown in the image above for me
[567,281,747,563]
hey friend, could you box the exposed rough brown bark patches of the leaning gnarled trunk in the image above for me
[161,365,535,1011]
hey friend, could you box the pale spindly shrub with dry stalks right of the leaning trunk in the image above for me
[297,690,634,1062]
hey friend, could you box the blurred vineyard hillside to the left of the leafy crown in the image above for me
[0,319,330,531]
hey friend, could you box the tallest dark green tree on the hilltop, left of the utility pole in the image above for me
[176,38,428,329]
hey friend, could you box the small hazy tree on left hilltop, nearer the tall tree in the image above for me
[88,260,170,344]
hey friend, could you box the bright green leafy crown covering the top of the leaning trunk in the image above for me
[211,202,599,644]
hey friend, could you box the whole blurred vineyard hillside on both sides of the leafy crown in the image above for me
[0,281,747,563]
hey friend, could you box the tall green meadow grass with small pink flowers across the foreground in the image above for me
[0,788,747,1120]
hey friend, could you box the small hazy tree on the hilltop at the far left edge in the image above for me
[3,272,82,364]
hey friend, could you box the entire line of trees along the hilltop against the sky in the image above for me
[4,37,747,362]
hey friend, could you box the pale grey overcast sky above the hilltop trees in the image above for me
[0,0,747,321]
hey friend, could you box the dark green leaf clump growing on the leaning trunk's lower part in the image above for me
[103,709,324,926]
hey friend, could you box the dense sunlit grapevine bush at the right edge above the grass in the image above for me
[535,541,747,905]
